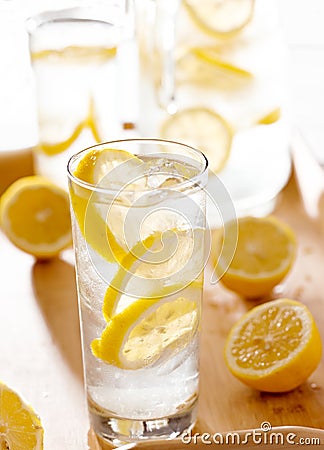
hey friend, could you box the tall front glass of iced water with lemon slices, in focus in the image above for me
[68,139,208,445]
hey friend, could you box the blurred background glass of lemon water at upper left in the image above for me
[27,0,122,187]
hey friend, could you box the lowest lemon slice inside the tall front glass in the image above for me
[91,282,201,370]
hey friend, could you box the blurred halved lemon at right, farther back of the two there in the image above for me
[213,216,297,298]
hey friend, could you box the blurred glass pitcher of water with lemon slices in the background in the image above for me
[138,0,291,220]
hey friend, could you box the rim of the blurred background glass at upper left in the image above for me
[25,5,114,35]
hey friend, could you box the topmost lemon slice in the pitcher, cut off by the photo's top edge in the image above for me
[183,0,254,38]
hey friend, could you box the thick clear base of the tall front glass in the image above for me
[89,404,197,446]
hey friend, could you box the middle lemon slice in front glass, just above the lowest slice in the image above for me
[102,228,204,321]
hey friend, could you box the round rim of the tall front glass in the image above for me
[67,138,208,195]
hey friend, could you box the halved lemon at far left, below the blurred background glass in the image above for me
[0,176,72,258]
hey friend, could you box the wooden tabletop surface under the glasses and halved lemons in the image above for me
[0,149,324,450]
